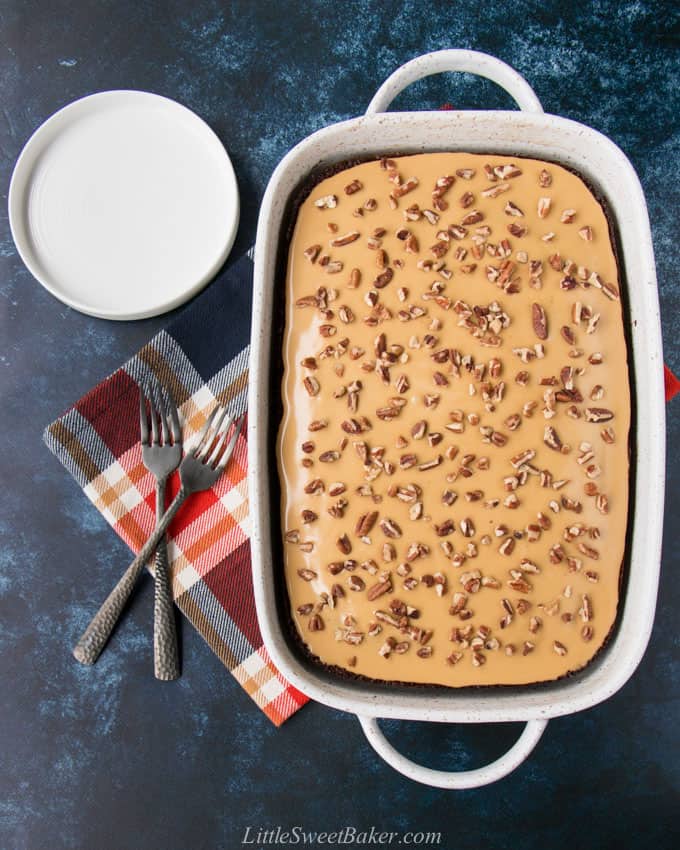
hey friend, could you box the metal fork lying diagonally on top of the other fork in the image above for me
[73,406,246,664]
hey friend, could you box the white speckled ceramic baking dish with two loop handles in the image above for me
[249,50,665,788]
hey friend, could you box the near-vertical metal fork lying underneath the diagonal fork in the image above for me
[139,385,182,682]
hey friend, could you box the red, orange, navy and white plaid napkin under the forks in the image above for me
[44,255,307,726]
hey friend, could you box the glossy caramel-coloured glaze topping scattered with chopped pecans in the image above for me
[278,153,630,687]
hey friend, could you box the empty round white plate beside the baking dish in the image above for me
[9,91,239,319]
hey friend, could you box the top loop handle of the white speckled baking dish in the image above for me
[366,50,543,115]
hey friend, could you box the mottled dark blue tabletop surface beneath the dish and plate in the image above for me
[0,0,680,850]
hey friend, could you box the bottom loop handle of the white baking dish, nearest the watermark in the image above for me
[359,716,548,790]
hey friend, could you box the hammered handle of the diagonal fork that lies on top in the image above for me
[73,487,188,664]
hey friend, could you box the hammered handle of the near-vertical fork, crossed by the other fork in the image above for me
[153,479,180,682]
